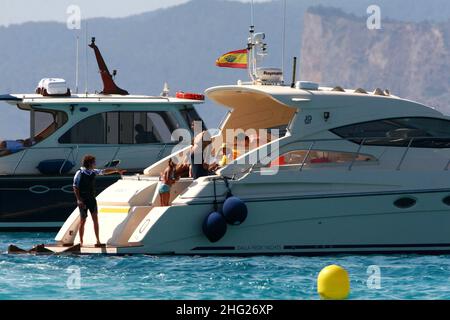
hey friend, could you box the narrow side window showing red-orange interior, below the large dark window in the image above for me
[270,150,376,166]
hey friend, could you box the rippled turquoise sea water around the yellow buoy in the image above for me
[0,233,450,300]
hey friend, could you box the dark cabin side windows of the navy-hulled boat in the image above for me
[59,111,177,144]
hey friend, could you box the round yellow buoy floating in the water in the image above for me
[317,264,350,300]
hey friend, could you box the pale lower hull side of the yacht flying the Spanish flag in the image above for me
[115,189,450,255]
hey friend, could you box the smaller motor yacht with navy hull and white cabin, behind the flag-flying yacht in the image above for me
[0,39,203,231]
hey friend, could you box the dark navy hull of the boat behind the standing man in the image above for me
[0,175,119,231]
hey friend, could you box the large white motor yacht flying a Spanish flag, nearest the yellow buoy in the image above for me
[40,29,450,255]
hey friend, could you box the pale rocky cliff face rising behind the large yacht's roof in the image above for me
[301,7,450,113]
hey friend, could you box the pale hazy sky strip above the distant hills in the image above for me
[0,0,270,26]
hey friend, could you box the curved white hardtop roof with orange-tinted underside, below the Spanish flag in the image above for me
[206,84,443,125]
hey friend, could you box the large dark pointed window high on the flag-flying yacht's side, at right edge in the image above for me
[331,117,450,148]
